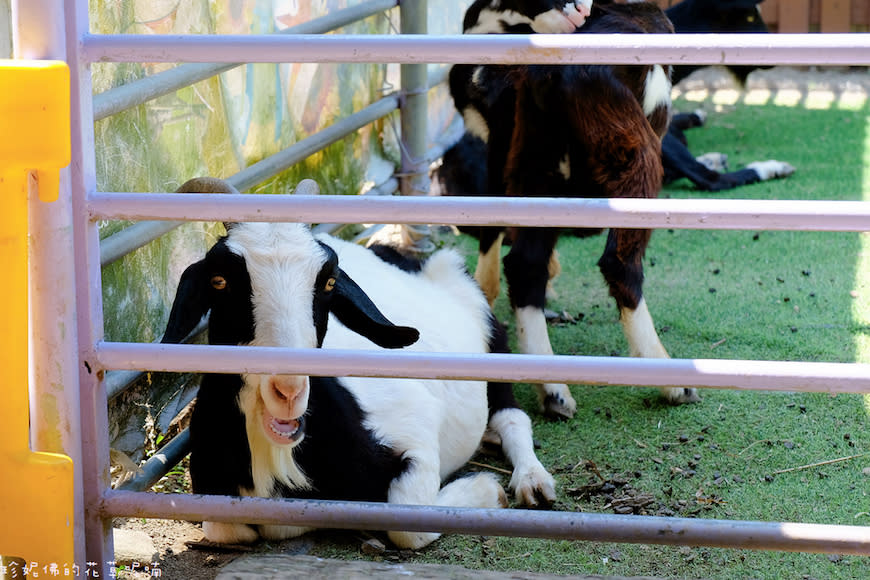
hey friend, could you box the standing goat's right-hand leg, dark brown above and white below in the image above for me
[598,228,701,404]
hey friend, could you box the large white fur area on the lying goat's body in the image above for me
[320,236,490,480]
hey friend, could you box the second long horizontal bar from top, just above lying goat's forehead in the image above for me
[89,192,870,231]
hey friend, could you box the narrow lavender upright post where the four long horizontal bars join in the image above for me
[63,0,114,578]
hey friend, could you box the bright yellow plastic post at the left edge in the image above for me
[0,60,75,576]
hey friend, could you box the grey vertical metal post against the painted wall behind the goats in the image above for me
[399,0,432,252]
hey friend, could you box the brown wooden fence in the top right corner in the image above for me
[656,0,870,32]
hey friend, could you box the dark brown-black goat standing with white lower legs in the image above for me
[445,1,698,417]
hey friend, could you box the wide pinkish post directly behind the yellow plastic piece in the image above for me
[11,0,85,564]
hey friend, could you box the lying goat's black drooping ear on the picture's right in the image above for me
[330,269,420,348]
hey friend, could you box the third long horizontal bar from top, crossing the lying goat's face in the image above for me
[89,342,870,393]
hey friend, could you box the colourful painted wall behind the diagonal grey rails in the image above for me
[94,0,468,459]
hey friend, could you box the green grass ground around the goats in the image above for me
[304,87,870,579]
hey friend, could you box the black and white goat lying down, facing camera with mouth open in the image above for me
[163,178,555,548]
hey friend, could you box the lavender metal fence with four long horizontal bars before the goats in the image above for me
[14,0,870,575]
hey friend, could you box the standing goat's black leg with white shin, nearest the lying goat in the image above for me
[504,228,577,419]
